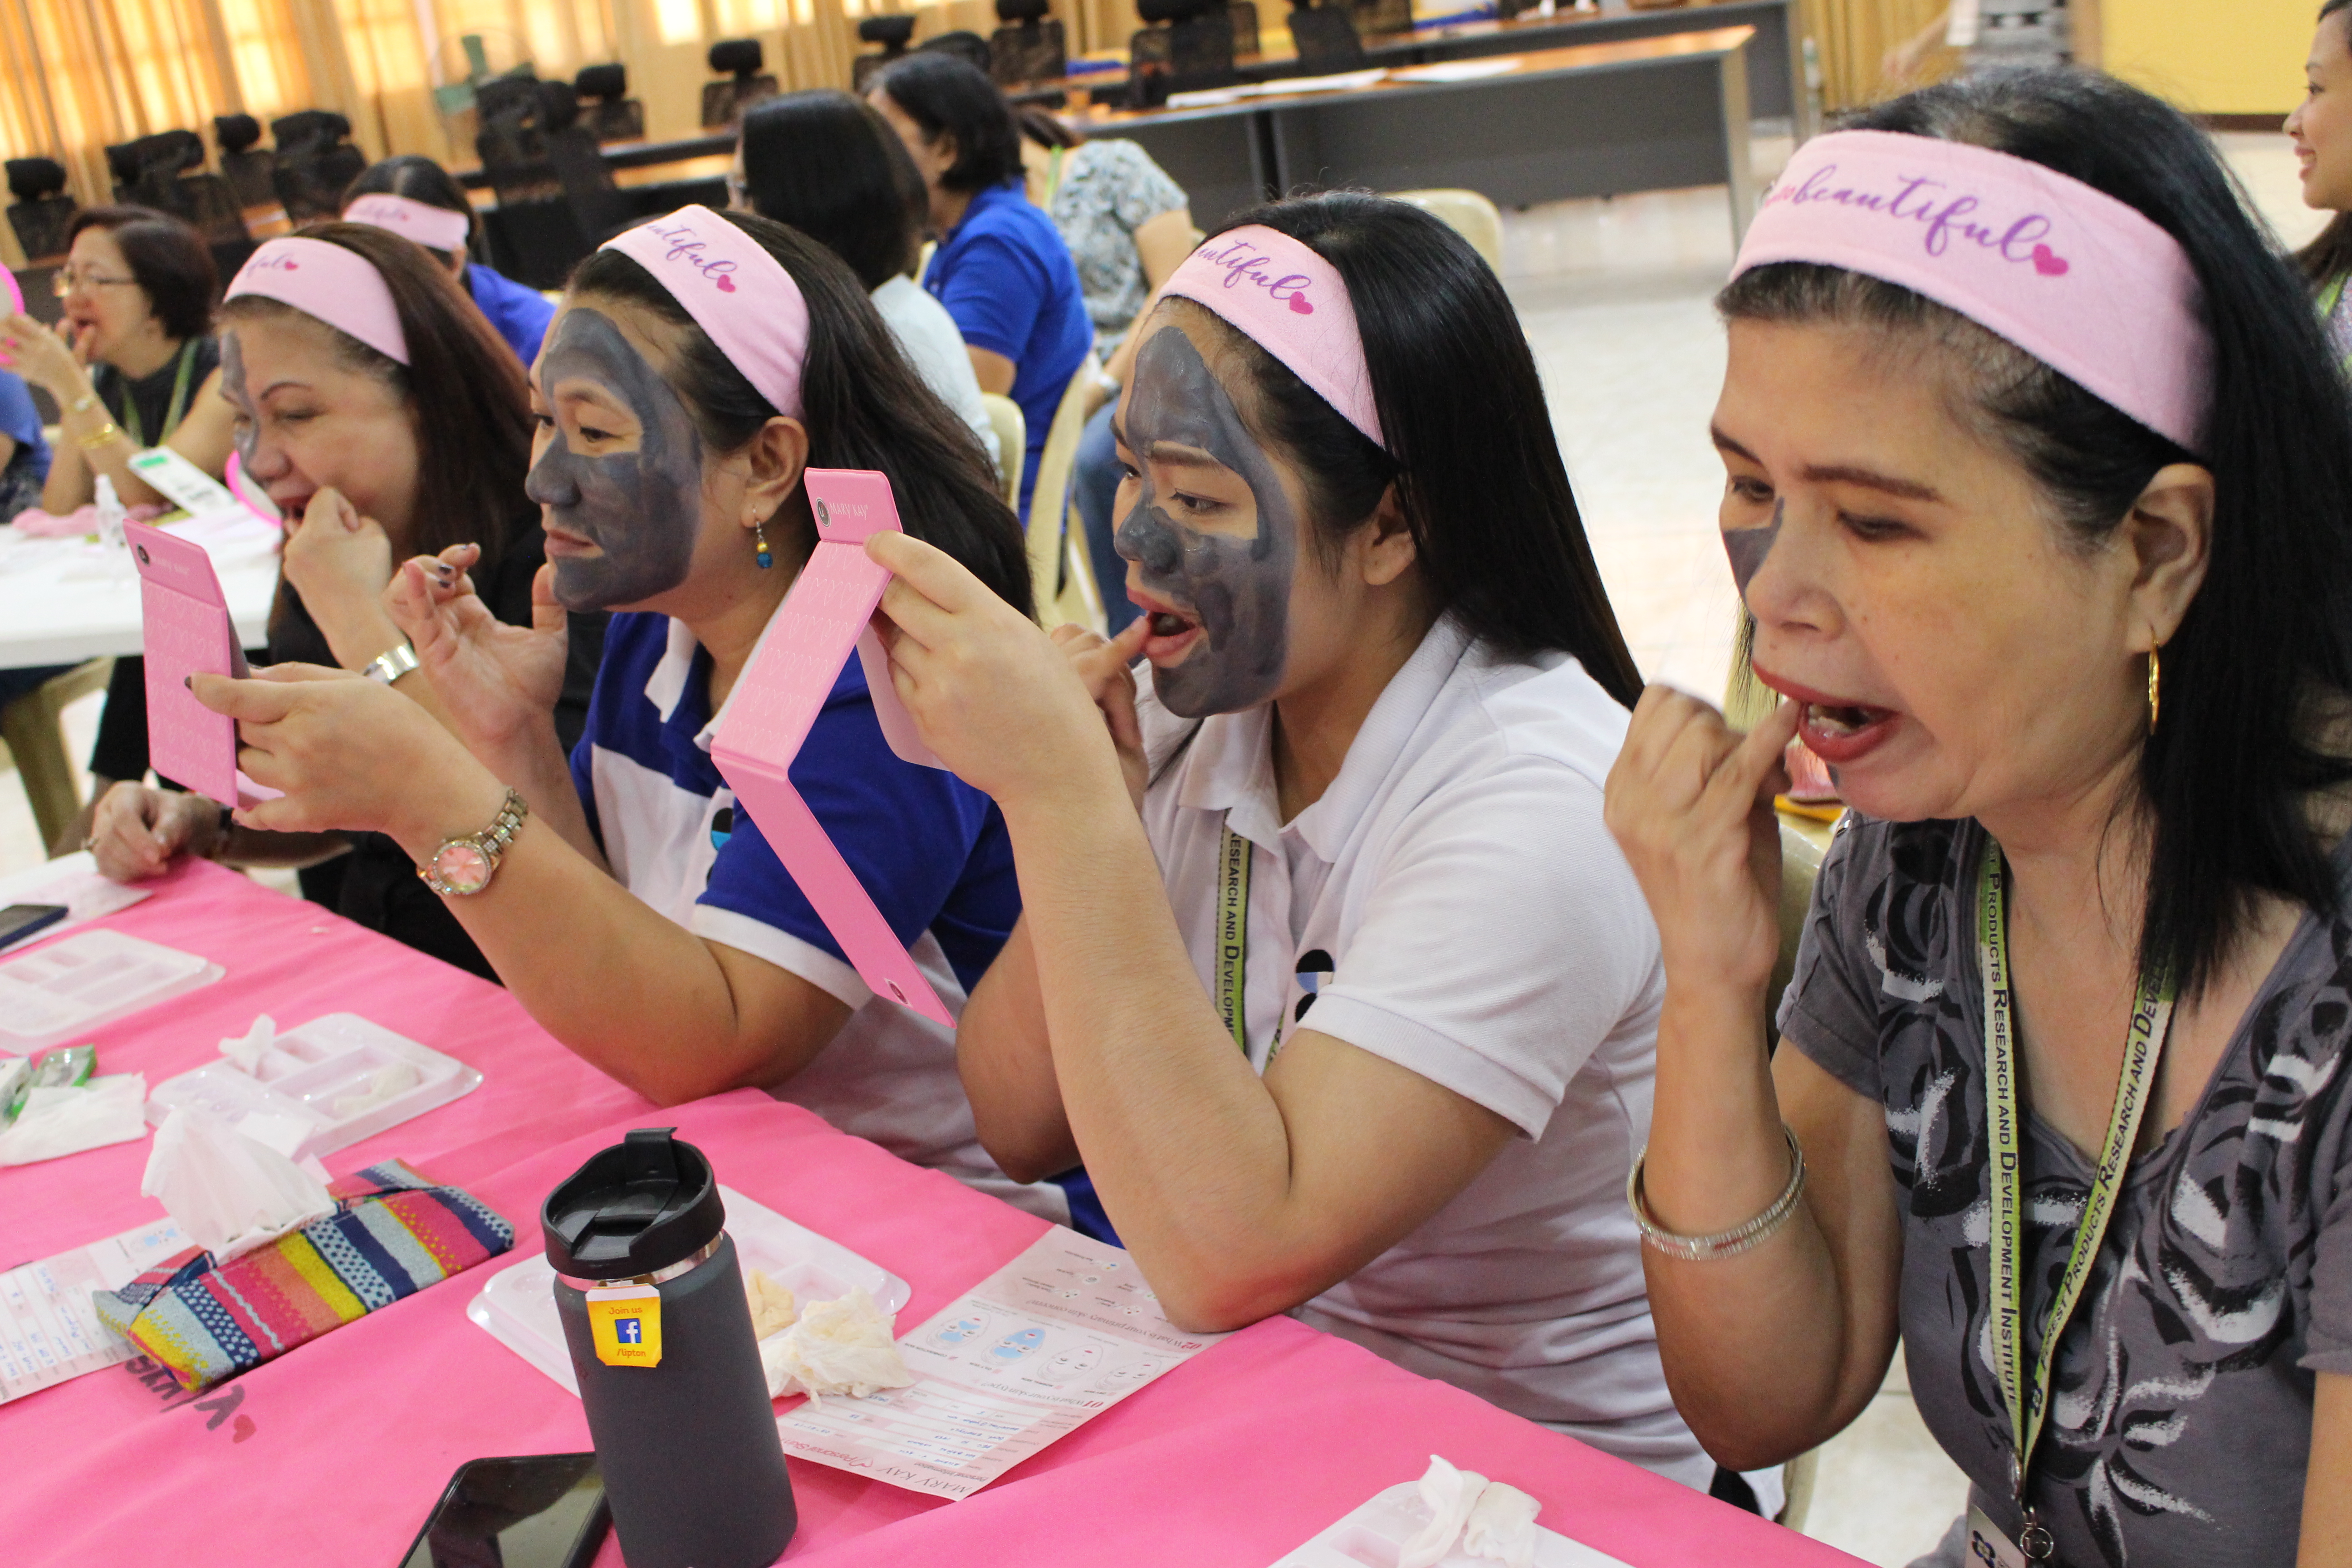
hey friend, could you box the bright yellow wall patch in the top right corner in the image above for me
[2100,0,2319,115]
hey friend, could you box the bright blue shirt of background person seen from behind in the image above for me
[922,179,1094,522]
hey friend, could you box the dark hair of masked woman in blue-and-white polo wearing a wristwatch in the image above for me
[572,211,1035,616]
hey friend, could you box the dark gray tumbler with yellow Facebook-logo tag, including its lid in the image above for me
[541,1126,800,1568]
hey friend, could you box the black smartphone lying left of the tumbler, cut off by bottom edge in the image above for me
[400,1453,612,1568]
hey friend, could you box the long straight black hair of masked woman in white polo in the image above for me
[1176,191,1642,708]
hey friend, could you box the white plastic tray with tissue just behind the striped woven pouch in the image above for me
[148,1013,482,1161]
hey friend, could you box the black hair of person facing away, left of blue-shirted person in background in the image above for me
[743,87,926,291]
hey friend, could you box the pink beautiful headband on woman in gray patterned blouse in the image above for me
[1731,132,2213,451]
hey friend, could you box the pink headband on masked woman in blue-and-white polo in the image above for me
[604,207,809,418]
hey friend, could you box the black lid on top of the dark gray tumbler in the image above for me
[539,1126,727,1279]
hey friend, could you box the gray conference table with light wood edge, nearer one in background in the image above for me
[1068,26,1754,240]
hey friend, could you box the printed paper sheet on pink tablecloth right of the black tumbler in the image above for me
[776,1225,1225,1498]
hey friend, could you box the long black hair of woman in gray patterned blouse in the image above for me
[1717,70,2352,995]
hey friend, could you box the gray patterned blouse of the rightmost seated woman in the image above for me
[1780,816,2352,1568]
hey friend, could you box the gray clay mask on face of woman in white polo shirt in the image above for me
[1117,327,1298,720]
